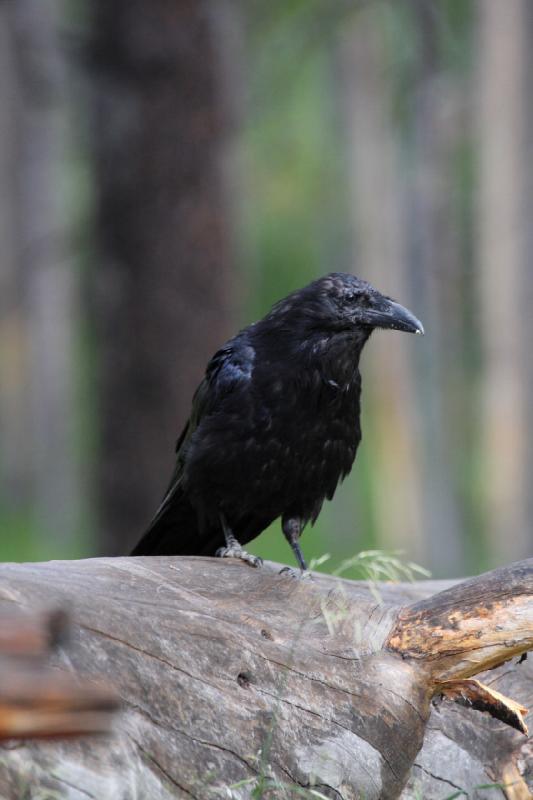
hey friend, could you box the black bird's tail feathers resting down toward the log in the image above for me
[131,481,224,556]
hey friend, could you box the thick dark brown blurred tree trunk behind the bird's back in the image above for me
[93,0,239,553]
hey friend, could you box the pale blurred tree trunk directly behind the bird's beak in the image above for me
[342,7,427,562]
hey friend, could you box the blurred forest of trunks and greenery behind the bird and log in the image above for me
[0,0,533,576]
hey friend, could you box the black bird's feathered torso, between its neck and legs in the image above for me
[185,342,361,518]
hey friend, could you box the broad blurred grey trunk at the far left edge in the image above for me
[0,0,79,553]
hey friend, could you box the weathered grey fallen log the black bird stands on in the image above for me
[0,558,533,800]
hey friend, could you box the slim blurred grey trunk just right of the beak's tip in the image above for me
[404,0,465,575]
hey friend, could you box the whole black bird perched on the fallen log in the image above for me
[132,272,424,570]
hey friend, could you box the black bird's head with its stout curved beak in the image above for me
[302,272,424,335]
